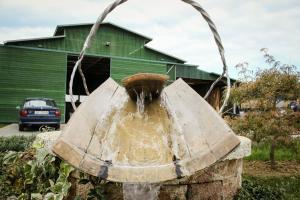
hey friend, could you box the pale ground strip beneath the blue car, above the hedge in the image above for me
[0,124,65,137]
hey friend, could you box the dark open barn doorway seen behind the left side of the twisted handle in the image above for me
[66,54,110,122]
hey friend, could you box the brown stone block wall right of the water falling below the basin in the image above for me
[159,159,243,200]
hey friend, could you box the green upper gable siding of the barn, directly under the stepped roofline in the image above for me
[7,24,182,63]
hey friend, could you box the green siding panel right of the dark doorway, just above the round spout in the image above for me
[111,59,166,83]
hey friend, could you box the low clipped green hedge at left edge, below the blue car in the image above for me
[0,136,35,152]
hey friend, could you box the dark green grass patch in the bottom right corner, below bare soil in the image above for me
[243,176,300,200]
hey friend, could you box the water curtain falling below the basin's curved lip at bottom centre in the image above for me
[123,183,160,200]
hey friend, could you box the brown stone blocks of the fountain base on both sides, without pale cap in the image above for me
[71,159,243,200]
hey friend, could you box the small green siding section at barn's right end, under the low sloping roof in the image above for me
[176,65,215,80]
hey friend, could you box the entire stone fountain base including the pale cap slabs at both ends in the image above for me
[37,132,251,200]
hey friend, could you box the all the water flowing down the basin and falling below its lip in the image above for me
[100,86,172,200]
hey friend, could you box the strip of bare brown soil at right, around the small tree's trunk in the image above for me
[243,161,300,177]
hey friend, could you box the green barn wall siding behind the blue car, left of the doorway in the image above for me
[0,46,66,122]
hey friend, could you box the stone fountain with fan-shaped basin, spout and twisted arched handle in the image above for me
[45,0,251,200]
